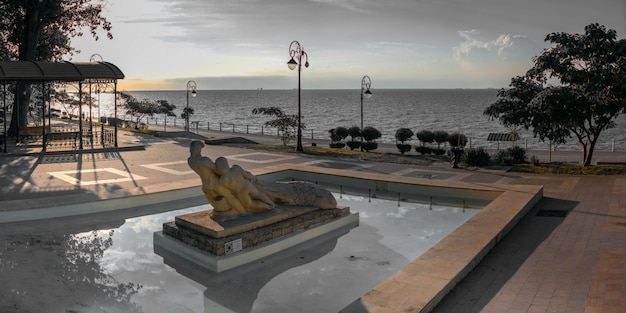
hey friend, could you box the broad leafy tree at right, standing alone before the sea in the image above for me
[484,24,626,166]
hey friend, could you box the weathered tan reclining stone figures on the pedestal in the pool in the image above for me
[187,140,337,218]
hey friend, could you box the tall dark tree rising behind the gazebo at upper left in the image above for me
[0,0,113,134]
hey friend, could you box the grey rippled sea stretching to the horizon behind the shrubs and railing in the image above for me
[94,89,626,150]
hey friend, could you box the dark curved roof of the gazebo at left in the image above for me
[0,61,124,82]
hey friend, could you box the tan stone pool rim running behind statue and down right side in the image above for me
[254,165,543,313]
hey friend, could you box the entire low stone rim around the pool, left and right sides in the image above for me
[0,164,543,312]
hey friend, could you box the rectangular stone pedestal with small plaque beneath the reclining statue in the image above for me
[154,206,359,272]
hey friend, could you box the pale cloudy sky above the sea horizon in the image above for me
[68,0,626,91]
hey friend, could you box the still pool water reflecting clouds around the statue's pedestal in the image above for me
[0,194,478,312]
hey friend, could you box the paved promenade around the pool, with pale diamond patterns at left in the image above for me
[0,125,626,312]
